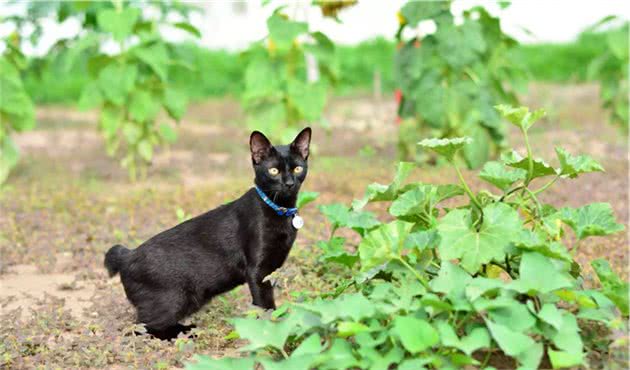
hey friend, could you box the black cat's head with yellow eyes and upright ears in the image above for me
[249,127,311,199]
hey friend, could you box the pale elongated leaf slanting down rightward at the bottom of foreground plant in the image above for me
[486,320,543,368]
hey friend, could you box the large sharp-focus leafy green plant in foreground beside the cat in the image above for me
[187,106,628,370]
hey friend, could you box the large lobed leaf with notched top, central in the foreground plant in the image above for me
[437,203,522,273]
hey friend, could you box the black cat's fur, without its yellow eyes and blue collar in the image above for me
[105,128,311,339]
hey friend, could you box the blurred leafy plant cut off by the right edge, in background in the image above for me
[588,17,630,132]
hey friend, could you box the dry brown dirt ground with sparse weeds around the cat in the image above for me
[0,85,628,369]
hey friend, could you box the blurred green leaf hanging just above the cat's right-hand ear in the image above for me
[287,79,327,121]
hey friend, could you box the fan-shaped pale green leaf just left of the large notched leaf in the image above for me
[358,220,413,271]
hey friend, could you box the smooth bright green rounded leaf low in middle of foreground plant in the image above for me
[392,316,440,354]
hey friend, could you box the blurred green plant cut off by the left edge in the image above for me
[0,34,35,185]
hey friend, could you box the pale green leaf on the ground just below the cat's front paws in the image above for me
[231,319,293,351]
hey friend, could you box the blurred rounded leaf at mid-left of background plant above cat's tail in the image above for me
[98,63,138,106]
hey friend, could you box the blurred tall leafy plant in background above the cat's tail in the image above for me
[3,1,200,179]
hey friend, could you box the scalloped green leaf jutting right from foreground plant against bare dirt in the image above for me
[557,203,624,240]
